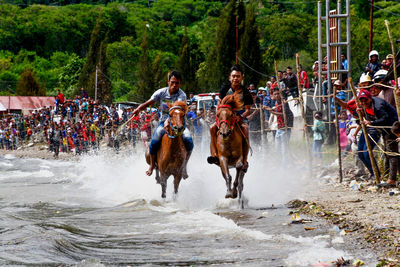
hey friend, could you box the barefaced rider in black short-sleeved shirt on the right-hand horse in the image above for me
[207,65,253,170]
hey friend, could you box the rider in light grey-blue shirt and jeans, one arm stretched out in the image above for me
[132,70,194,179]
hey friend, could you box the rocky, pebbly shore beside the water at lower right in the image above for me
[288,156,400,266]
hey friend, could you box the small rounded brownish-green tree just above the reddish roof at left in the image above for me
[15,69,46,96]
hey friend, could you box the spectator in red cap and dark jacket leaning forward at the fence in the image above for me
[357,89,399,185]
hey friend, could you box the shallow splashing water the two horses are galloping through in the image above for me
[0,152,375,266]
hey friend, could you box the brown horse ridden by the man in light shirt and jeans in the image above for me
[146,101,188,198]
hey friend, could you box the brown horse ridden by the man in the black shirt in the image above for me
[216,94,246,208]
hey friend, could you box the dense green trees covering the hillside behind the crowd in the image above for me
[0,0,400,102]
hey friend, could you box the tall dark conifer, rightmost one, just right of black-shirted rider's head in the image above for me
[239,1,261,86]
